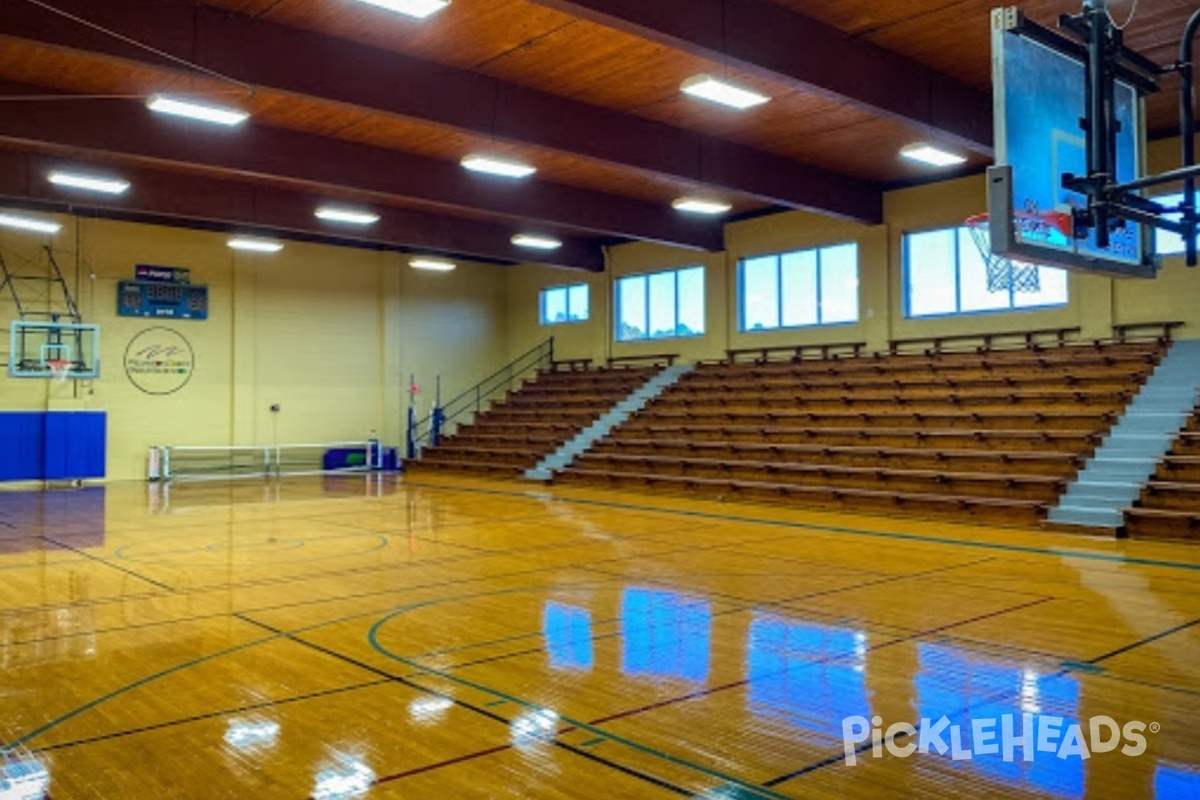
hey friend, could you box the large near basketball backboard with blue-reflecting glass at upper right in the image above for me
[988,7,1156,277]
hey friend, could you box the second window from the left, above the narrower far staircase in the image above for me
[617,266,704,342]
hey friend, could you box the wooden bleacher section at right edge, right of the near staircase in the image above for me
[1126,409,1200,539]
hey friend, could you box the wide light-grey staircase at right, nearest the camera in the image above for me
[1049,341,1200,530]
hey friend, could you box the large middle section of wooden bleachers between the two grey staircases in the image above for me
[559,338,1166,524]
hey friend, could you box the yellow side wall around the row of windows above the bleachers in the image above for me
[509,139,1200,367]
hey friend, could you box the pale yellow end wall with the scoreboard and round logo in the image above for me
[0,216,508,479]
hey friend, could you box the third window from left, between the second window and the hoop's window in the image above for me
[738,243,858,331]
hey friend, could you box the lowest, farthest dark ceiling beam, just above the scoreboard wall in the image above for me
[0,150,604,267]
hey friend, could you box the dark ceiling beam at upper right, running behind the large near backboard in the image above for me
[533,0,992,156]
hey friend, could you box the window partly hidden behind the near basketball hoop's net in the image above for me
[904,227,1067,318]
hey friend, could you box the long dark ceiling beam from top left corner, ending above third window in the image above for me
[0,0,883,223]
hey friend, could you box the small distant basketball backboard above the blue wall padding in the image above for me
[8,320,100,379]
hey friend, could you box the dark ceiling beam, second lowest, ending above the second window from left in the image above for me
[0,84,724,251]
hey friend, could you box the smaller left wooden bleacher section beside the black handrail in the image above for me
[404,356,674,477]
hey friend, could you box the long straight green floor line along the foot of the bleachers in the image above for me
[406,481,1200,572]
